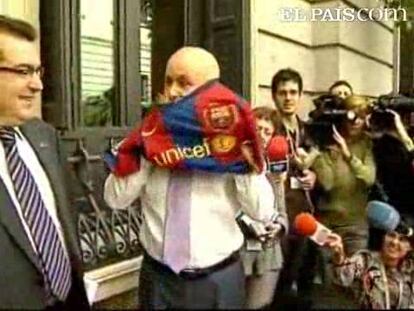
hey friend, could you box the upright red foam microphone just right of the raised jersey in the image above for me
[266,136,289,173]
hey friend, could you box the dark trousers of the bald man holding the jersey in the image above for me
[138,254,245,309]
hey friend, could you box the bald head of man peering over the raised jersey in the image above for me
[164,47,220,100]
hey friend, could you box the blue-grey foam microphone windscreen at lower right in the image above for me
[367,201,400,231]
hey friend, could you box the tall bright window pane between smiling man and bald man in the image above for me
[80,0,115,126]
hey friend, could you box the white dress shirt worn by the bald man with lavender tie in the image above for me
[104,158,274,269]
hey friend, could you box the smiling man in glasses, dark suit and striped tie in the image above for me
[0,16,89,310]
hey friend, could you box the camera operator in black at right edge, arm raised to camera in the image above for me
[369,97,414,226]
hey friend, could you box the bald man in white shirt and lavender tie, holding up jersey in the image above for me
[104,47,274,309]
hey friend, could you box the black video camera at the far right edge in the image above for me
[370,95,414,131]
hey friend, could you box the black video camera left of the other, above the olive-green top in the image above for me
[305,95,356,149]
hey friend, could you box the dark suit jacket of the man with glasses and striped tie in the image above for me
[0,119,89,310]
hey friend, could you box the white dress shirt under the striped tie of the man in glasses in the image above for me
[0,128,67,254]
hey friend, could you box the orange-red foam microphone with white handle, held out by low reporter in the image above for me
[293,213,332,246]
